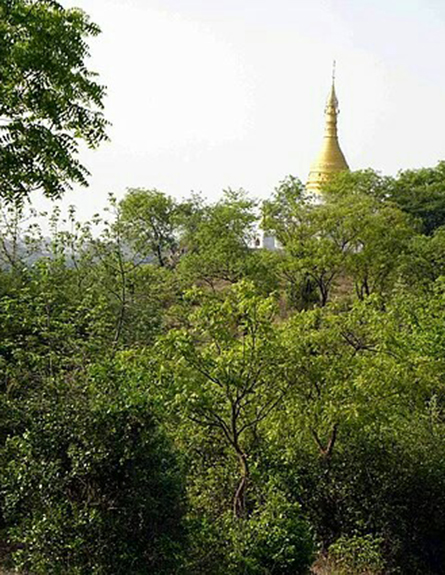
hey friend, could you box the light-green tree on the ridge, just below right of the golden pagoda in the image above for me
[324,170,418,299]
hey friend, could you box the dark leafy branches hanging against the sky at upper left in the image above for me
[0,0,107,203]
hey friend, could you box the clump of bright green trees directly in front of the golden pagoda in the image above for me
[263,172,414,309]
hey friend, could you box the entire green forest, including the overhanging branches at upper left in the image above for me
[0,0,445,575]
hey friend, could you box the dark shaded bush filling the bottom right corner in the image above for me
[280,414,445,575]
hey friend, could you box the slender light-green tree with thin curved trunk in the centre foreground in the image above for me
[167,282,289,518]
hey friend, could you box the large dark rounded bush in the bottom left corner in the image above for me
[0,367,183,575]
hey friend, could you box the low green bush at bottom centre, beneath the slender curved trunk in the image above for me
[184,488,315,575]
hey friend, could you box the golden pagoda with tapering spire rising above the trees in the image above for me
[306,62,349,193]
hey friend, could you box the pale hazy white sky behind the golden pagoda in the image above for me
[50,0,445,217]
